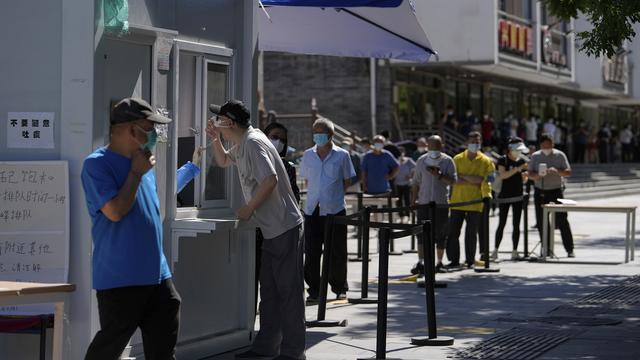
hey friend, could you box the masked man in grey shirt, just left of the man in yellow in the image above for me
[412,135,458,273]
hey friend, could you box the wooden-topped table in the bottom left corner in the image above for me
[0,281,76,360]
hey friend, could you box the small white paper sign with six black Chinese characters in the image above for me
[7,112,55,149]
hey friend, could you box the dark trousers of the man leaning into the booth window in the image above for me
[252,225,305,359]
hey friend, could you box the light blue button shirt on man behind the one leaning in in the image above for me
[300,145,356,216]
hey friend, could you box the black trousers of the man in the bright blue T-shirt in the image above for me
[85,279,181,360]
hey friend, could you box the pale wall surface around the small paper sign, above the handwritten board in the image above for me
[0,0,62,160]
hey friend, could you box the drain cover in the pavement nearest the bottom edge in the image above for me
[452,328,578,360]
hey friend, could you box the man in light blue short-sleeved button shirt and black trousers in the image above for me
[300,118,356,302]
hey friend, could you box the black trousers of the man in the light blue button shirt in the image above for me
[304,208,349,297]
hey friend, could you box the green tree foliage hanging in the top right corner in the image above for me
[543,0,640,57]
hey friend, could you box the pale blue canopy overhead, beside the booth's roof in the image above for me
[258,0,435,62]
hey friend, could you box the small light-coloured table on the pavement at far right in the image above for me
[542,204,636,263]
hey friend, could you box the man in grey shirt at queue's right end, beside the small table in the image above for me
[529,134,575,257]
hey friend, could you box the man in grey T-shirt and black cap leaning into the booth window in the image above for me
[207,100,305,360]
